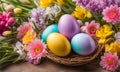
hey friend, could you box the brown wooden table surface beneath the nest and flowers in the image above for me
[0,59,120,72]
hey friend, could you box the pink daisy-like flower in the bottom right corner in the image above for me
[100,53,119,71]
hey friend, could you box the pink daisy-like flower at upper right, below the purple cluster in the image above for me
[102,5,120,24]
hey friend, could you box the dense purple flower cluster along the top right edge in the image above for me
[73,0,120,13]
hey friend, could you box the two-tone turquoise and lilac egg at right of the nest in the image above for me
[71,33,96,55]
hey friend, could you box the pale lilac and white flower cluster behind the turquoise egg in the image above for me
[30,4,61,29]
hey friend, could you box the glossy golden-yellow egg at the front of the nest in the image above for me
[47,33,71,57]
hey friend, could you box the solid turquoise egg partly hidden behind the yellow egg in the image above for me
[41,24,58,43]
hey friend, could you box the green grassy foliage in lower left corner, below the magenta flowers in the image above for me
[0,38,22,68]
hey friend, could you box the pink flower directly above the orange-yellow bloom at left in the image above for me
[17,23,32,39]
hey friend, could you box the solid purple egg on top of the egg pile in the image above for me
[58,14,80,39]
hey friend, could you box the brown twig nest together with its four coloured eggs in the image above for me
[39,14,103,66]
